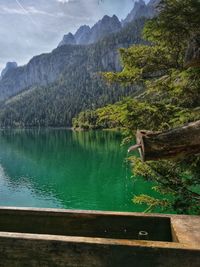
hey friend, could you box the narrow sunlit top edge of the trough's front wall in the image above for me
[0,232,200,251]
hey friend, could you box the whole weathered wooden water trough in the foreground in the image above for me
[0,207,200,267]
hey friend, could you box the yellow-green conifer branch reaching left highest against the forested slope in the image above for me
[103,45,176,84]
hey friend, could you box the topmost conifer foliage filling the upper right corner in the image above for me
[144,0,200,68]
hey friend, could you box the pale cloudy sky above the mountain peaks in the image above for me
[0,0,148,72]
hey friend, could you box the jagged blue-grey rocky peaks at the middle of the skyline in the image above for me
[58,15,121,46]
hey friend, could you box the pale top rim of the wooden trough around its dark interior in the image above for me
[0,207,200,250]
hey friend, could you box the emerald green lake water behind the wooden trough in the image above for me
[0,129,161,214]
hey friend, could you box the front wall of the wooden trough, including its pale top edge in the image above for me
[0,233,200,267]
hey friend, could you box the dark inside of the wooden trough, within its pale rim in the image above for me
[0,209,171,241]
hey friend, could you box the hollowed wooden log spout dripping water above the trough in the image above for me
[129,121,200,161]
